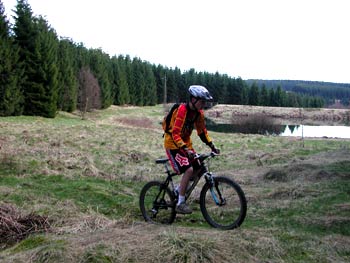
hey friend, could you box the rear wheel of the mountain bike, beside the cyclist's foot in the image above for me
[139,181,176,224]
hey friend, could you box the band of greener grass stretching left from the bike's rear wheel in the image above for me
[0,175,141,218]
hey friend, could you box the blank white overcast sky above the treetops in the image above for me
[1,0,350,83]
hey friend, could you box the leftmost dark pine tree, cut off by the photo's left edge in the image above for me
[0,1,23,116]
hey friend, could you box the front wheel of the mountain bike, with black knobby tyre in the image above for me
[200,176,247,230]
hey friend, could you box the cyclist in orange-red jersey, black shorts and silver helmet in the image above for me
[164,85,220,214]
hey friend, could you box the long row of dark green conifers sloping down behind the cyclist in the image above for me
[0,0,324,118]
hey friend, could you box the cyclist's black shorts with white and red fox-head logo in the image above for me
[165,149,199,174]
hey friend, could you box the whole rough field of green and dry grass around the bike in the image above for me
[0,105,350,262]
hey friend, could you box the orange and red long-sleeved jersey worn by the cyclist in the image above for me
[164,104,211,152]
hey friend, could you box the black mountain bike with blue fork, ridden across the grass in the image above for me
[139,152,247,230]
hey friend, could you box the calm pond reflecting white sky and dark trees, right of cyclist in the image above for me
[206,119,350,138]
